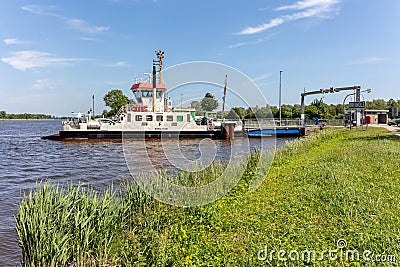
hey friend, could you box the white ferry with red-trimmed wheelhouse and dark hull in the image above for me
[42,50,244,140]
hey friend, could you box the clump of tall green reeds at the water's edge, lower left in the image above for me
[16,183,121,266]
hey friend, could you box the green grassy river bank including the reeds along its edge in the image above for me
[16,128,400,266]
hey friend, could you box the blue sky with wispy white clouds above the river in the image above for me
[0,0,400,115]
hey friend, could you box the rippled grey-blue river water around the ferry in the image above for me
[0,120,290,266]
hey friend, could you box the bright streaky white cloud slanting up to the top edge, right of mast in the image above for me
[237,0,339,35]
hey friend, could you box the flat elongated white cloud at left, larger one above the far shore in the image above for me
[1,50,87,71]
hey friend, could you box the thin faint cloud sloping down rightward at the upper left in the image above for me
[21,5,110,34]
